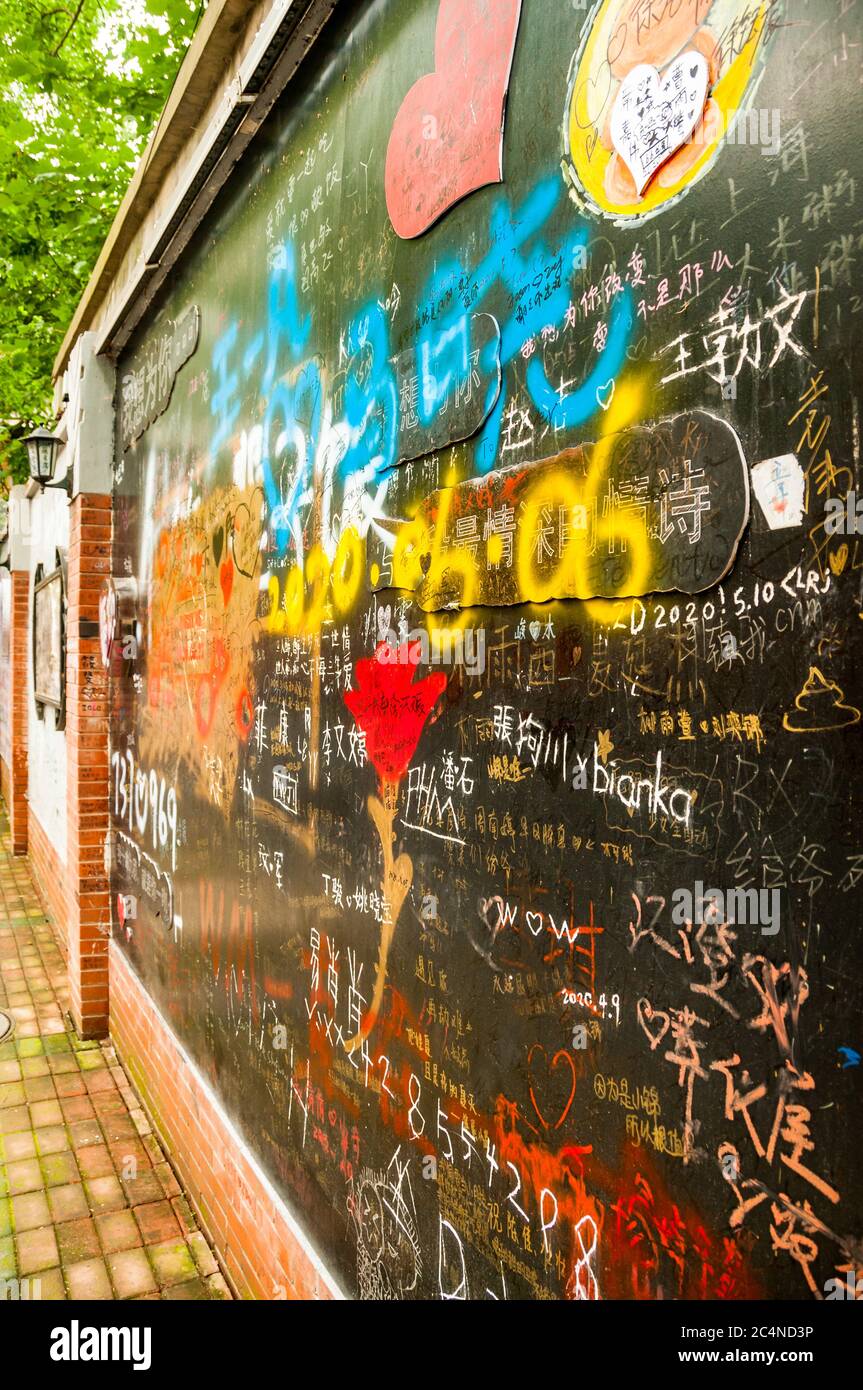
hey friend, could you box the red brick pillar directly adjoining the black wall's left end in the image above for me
[65,492,111,1038]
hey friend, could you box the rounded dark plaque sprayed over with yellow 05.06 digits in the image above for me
[379,381,749,621]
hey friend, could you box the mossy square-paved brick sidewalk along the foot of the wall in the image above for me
[0,805,231,1300]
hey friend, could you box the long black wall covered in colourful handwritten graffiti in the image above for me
[101,0,863,1300]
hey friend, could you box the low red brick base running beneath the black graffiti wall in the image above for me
[110,947,338,1300]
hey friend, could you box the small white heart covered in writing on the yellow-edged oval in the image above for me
[611,49,709,195]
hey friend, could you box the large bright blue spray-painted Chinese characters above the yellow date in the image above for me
[204,175,634,555]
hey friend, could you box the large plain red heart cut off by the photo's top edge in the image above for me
[385,0,521,238]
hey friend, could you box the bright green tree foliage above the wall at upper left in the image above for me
[0,0,206,493]
